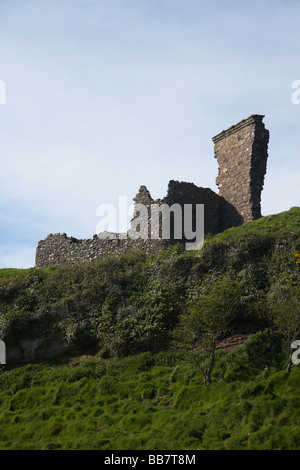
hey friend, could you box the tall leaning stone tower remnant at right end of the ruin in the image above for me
[213,114,269,229]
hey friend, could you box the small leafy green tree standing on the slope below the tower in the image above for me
[173,278,243,386]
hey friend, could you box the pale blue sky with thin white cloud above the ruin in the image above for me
[0,0,300,268]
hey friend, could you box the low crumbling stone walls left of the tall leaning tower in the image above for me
[35,181,221,268]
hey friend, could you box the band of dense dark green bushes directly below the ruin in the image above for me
[0,208,300,355]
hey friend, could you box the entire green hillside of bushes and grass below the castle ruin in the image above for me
[0,208,300,450]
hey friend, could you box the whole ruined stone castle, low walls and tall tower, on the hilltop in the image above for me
[36,114,269,268]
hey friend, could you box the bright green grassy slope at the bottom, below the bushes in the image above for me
[0,332,300,450]
